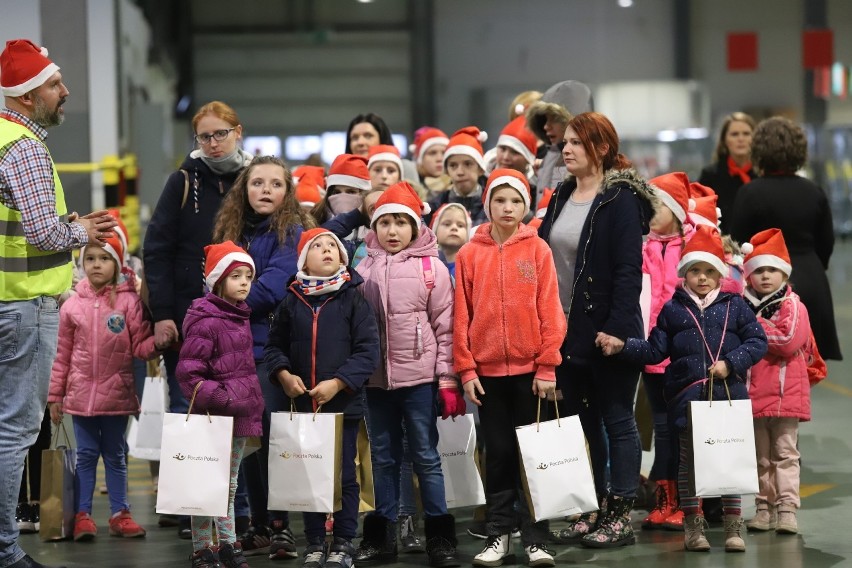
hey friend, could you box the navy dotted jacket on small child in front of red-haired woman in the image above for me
[621,288,767,429]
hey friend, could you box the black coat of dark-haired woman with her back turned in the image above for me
[731,175,843,361]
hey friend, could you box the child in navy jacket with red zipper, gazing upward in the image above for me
[264,228,379,568]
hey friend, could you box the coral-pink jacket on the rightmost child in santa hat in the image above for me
[747,287,811,421]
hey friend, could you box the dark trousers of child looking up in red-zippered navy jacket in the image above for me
[302,419,361,543]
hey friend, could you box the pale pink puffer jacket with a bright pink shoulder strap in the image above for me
[357,226,453,390]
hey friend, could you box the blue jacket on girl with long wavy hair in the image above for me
[238,218,302,361]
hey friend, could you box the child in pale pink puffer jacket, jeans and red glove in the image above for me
[355,181,465,567]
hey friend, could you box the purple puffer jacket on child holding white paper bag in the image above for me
[177,293,263,437]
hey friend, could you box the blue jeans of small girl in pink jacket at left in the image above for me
[71,416,130,515]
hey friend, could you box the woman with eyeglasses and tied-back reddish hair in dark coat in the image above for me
[143,101,253,539]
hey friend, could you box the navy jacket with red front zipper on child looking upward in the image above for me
[264,270,379,419]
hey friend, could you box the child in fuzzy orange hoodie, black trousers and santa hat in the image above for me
[453,169,568,566]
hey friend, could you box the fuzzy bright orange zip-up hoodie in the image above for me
[453,223,568,383]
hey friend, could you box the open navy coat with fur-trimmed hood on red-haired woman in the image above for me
[538,170,653,364]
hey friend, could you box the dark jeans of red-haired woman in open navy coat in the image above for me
[556,357,642,498]
